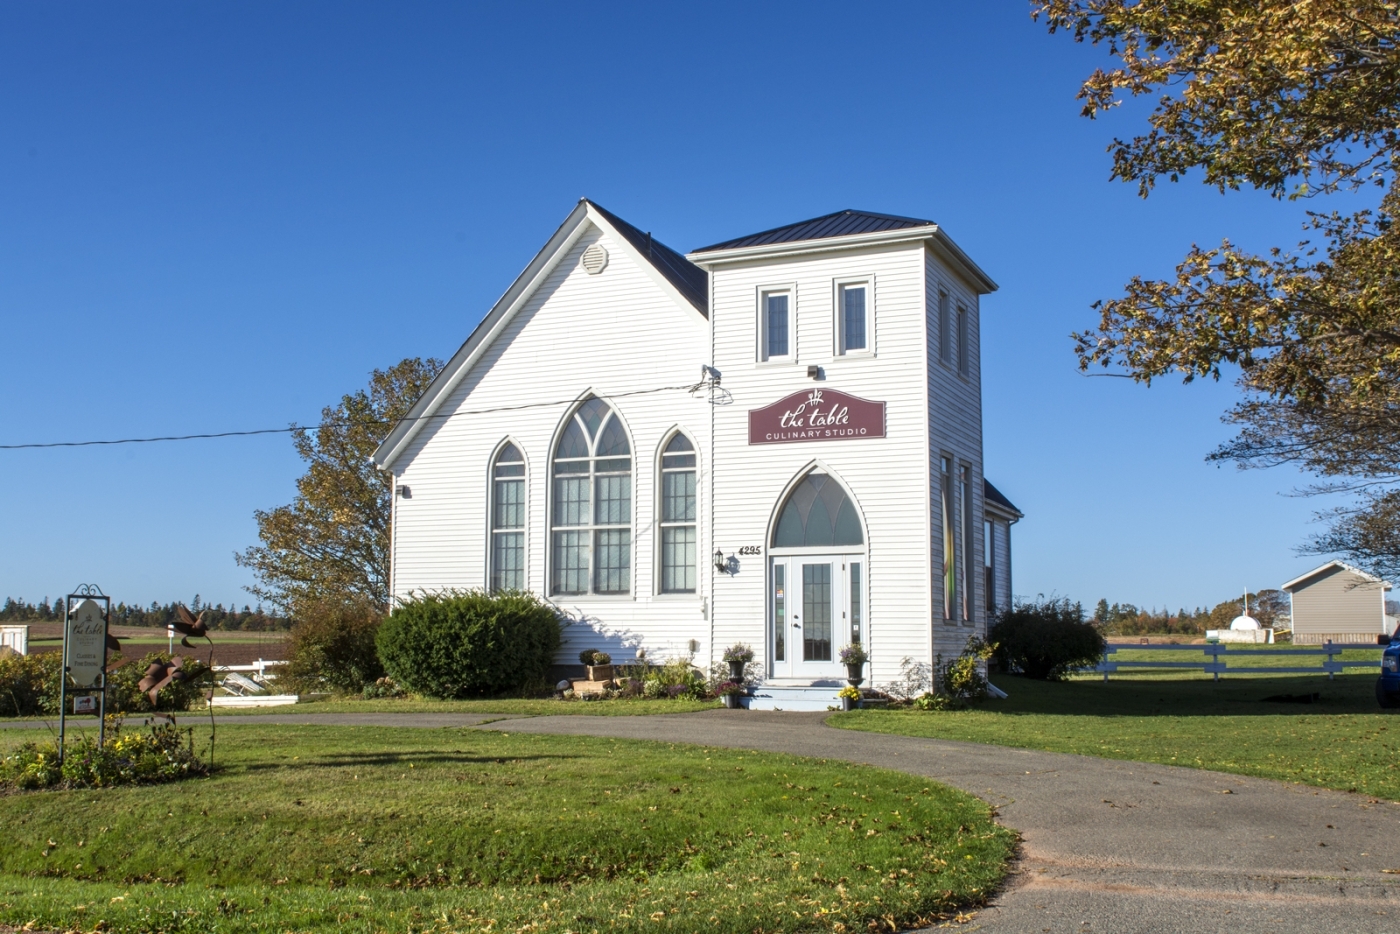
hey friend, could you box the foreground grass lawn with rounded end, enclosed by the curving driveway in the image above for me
[0,728,1015,934]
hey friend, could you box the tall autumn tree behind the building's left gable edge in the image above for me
[234,357,442,616]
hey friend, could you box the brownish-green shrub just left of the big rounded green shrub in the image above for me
[277,601,384,695]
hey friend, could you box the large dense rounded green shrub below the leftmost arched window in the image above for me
[378,591,561,697]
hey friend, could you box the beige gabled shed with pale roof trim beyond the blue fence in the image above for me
[1282,562,1390,646]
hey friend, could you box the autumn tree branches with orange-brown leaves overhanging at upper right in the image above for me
[1032,0,1400,573]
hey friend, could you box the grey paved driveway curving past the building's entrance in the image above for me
[3,710,1400,934]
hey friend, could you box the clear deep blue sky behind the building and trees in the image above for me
[0,0,1366,608]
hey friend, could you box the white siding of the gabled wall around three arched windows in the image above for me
[393,228,710,664]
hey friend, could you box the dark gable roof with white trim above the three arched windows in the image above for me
[371,197,710,468]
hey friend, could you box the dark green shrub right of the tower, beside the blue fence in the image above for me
[987,599,1103,681]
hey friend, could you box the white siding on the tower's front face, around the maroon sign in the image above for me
[711,245,940,683]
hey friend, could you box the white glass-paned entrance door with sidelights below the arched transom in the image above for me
[769,555,865,681]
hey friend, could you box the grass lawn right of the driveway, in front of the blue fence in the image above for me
[829,672,1400,801]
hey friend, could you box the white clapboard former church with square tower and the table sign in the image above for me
[375,200,1021,707]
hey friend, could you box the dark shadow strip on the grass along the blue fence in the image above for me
[980,674,1382,717]
